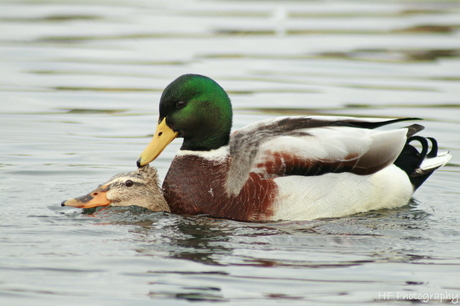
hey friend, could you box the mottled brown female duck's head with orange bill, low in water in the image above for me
[61,165,170,212]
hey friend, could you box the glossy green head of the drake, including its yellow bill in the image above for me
[137,74,232,167]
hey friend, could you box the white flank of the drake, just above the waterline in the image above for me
[273,165,413,220]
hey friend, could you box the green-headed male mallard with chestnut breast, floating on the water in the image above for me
[137,74,451,221]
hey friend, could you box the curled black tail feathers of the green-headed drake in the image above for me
[394,136,438,191]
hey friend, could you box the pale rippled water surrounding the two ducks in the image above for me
[0,0,460,305]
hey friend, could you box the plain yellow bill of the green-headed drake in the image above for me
[137,118,178,167]
